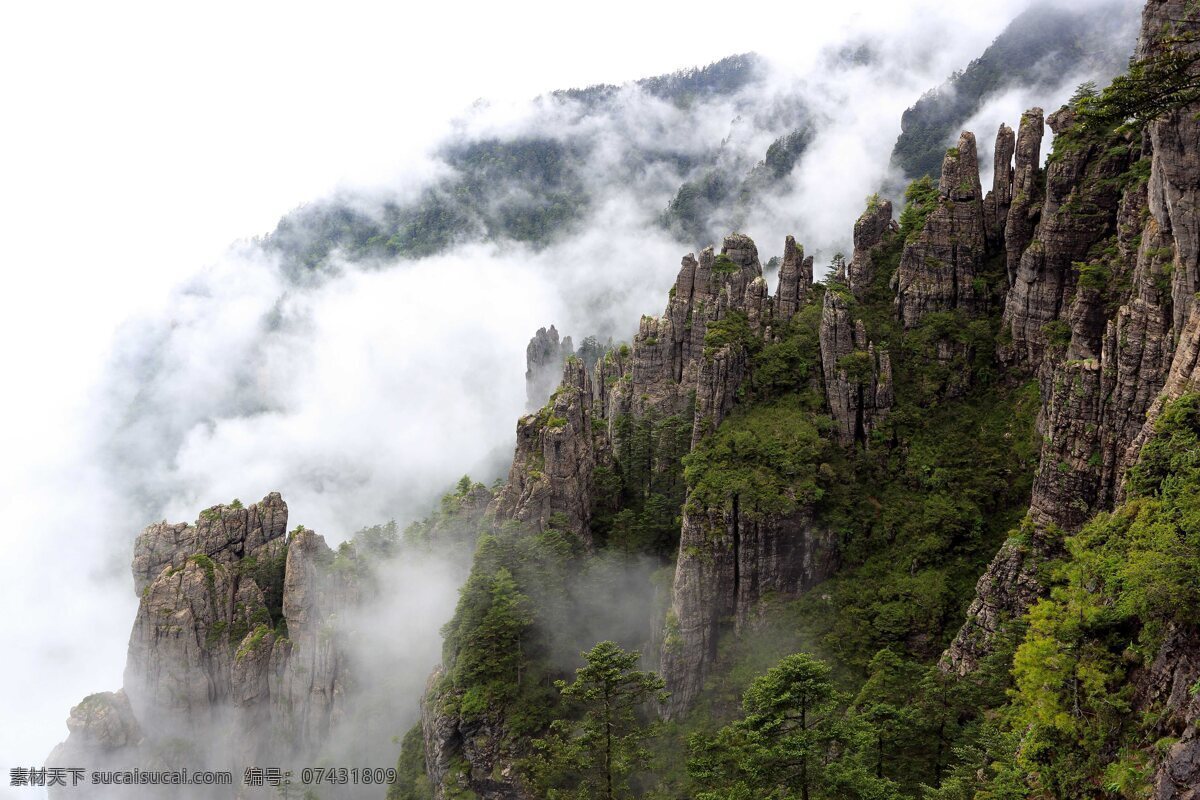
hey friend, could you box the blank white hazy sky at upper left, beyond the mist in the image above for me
[0,0,1080,782]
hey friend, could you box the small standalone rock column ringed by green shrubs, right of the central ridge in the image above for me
[821,283,892,445]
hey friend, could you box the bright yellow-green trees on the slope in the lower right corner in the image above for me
[955,395,1200,799]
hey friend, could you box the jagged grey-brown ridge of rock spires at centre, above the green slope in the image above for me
[492,234,777,547]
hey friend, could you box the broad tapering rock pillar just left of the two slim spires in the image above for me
[895,131,988,327]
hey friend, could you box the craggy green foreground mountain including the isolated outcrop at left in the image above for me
[42,0,1200,800]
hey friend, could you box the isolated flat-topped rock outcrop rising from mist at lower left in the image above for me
[52,493,358,786]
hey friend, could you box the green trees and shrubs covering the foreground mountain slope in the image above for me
[390,20,1200,800]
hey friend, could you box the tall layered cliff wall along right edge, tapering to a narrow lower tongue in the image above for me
[943,0,1200,700]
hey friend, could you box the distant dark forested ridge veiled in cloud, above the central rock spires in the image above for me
[265,54,805,278]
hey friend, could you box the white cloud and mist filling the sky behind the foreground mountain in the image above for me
[0,0,1137,765]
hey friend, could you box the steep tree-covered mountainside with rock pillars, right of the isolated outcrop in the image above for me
[392,1,1200,798]
